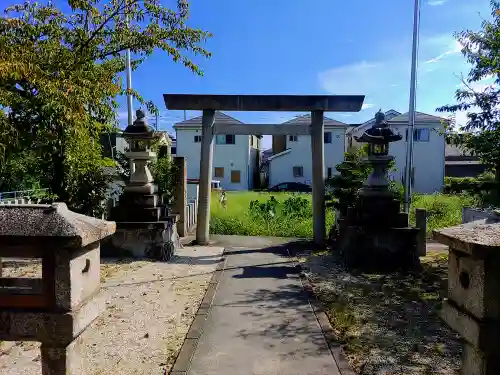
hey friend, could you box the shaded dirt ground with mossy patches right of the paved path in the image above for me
[300,251,461,375]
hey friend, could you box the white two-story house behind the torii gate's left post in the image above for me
[174,111,262,190]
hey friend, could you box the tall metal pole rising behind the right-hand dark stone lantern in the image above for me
[404,0,420,213]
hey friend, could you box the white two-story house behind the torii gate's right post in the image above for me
[267,115,347,187]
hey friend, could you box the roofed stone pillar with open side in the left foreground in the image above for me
[0,203,116,375]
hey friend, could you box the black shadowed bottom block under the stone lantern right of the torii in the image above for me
[339,226,420,272]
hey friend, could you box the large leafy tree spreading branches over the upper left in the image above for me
[0,0,210,212]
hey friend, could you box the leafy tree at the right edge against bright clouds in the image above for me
[437,1,500,188]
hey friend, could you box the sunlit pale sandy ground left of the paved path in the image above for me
[0,246,223,375]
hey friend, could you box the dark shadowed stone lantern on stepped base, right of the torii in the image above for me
[337,111,420,271]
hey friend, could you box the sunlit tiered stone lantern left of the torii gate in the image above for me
[112,110,179,260]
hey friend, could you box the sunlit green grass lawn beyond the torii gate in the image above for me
[210,191,472,238]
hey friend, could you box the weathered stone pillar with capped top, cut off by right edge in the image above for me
[434,222,500,375]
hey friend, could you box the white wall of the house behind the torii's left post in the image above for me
[176,131,249,190]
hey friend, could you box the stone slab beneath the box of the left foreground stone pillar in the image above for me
[0,294,105,346]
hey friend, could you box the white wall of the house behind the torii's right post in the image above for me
[269,126,345,187]
